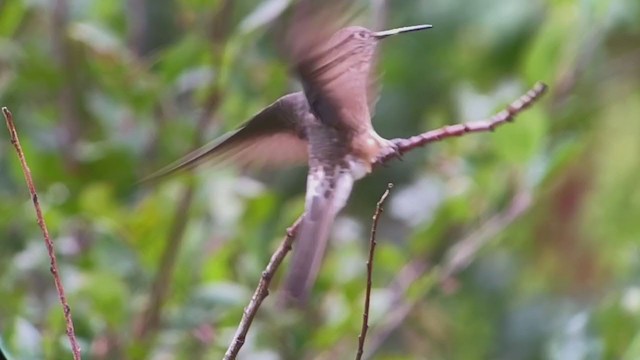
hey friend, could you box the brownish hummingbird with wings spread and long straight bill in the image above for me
[152,11,431,304]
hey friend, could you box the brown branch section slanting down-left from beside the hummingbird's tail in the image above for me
[224,216,302,360]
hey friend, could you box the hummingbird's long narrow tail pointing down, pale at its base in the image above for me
[284,167,354,304]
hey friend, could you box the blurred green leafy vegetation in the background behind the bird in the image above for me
[0,0,640,359]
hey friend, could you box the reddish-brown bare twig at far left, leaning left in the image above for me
[2,107,80,360]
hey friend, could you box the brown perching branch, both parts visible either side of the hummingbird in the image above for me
[224,82,547,360]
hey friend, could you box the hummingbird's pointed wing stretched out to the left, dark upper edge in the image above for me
[143,92,312,181]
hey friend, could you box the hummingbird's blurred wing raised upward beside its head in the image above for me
[286,0,377,128]
